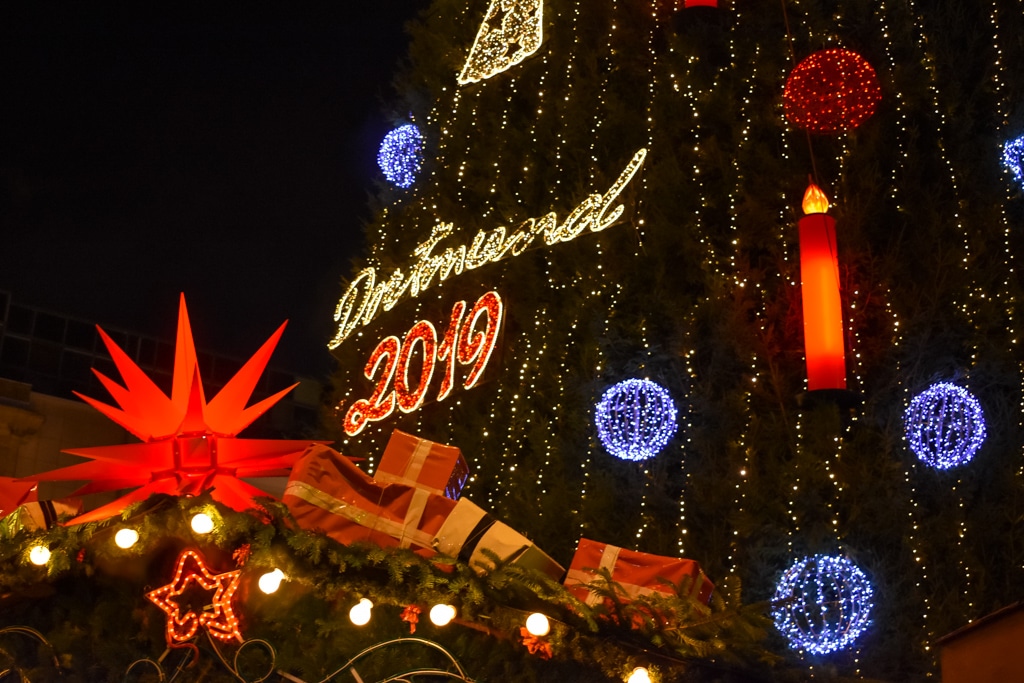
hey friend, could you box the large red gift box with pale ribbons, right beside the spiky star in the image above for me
[282,443,455,554]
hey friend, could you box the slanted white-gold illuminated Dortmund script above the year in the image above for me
[328,150,647,349]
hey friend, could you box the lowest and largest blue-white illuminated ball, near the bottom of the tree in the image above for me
[771,555,874,654]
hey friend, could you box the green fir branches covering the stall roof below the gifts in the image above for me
[0,497,771,681]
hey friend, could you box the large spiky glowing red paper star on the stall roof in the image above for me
[33,295,312,524]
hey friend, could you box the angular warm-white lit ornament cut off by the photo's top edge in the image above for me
[459,0,544,85]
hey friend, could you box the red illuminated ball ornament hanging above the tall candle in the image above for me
[782,49,882,133]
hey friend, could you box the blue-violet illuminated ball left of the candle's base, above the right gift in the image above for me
[594,379,676,460]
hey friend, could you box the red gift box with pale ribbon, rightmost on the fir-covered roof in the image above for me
[564,539,715,605]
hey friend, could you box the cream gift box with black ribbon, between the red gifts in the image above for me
[433,498,565,581]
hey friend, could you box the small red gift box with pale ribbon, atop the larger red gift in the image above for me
[374,429,469,501]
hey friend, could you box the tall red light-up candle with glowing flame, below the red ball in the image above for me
[800,182,846,391]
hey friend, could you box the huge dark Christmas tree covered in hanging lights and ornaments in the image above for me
[328,0,1024,680]
